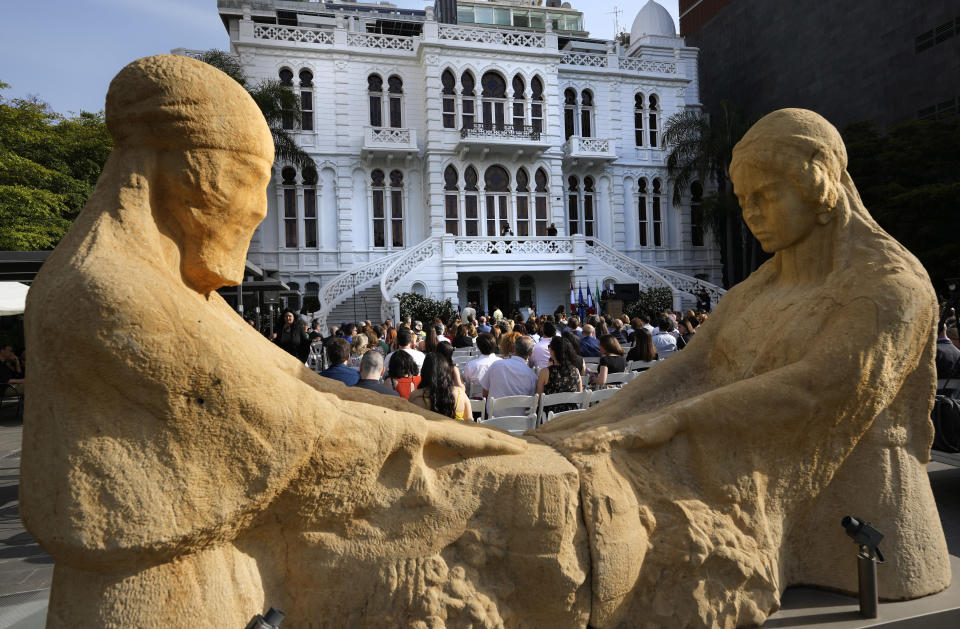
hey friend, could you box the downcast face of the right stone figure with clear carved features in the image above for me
[733,168,819,253]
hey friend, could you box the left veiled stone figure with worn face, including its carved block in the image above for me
[21,56,589,628]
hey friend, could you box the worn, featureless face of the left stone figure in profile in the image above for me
[162,149,271,294]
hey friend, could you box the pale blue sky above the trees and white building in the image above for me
[0,0,678,113]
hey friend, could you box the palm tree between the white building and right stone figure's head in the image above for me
[663,101,762,287]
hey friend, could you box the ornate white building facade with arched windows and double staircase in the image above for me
[219,0,722,324]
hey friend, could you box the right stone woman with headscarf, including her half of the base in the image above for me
[537,109,950,627]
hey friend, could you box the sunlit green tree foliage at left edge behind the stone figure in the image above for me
[0,83,113,251]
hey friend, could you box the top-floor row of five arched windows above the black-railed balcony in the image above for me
[440,68,544,132]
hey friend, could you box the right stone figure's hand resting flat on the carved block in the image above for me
[538,413,682,452]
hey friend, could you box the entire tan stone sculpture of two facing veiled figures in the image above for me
[21,56,949,629]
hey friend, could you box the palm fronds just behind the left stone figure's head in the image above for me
[195,50,316,169]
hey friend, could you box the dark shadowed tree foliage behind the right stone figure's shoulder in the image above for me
[843,117,960,288]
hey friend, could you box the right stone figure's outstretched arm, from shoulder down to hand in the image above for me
[546,297,926,451]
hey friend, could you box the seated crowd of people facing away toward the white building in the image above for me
[273,307,708,420]
